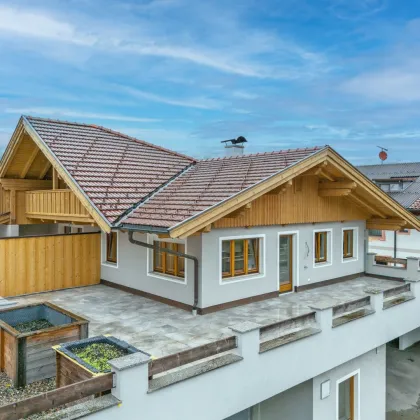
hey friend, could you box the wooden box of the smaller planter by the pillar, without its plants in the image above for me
[54,335,140,388]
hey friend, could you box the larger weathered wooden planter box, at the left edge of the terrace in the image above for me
[0,302,89,387]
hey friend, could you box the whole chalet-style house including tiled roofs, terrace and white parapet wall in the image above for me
[0,116,420,420]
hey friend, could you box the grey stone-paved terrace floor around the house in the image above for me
[13,277,402,357]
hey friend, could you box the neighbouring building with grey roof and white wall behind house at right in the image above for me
[358,162,420,258]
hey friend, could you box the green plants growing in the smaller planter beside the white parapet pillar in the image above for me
[72,343,128,372]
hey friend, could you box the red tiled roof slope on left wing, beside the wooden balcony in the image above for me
[26,117,195,223]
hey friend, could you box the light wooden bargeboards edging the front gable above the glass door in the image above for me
[169,146,420,238]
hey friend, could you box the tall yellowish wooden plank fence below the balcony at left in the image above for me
[0,233,101,297]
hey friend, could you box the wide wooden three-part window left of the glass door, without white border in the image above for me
[222,238,260,278]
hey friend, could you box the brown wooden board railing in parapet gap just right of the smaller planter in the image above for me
[149,336,237,378]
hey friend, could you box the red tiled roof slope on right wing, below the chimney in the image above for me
[121,147,321,228]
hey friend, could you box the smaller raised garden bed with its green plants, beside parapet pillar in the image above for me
[54,335,140,388]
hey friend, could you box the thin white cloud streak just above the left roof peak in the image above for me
[4,107,160,123]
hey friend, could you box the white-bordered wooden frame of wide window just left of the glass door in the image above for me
[219,234,265,285]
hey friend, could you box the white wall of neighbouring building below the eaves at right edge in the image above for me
[369,229,420,258]
